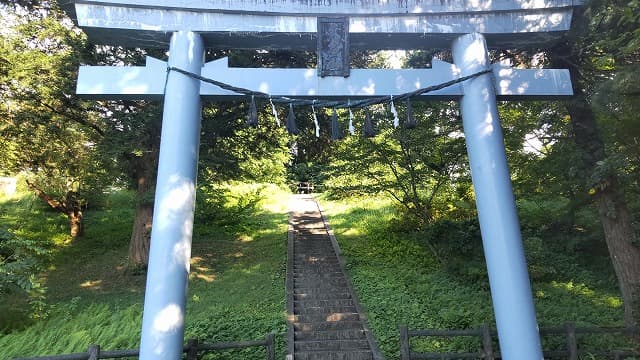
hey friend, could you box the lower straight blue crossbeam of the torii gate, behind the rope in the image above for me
[76,57,573,101]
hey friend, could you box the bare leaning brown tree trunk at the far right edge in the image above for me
[549,35,640,326]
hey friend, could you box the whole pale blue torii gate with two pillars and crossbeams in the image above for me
[73,0,580,360]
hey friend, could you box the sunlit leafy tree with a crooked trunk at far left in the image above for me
[0,4,102,237]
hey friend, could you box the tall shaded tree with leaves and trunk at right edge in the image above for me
[548,0,640,325]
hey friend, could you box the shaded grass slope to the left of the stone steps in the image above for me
[0,186,288,359]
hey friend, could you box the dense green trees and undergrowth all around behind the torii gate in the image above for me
[0,0,640,357]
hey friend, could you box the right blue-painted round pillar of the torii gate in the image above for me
[453,33,542,360]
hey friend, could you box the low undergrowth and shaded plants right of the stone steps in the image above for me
[321,196,628,359]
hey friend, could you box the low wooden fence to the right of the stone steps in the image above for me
[400,323,640,360]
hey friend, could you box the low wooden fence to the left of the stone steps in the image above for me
[14,334,276,360]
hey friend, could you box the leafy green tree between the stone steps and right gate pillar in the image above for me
[329,103,468,227]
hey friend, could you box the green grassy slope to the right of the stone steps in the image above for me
[320,197,626,359]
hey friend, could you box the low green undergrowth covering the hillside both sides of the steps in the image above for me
[0,183,626,359]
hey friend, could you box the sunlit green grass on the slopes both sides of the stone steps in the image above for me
[0,184,623,359]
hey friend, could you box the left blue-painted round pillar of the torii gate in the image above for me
[140,31,204,360]
